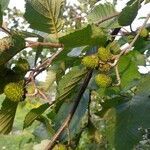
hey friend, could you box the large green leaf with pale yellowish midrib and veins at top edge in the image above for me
[24,0,64,34]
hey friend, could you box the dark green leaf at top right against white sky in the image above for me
[118,0,140,26]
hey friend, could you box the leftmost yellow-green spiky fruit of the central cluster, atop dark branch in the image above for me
[82,55,99,69]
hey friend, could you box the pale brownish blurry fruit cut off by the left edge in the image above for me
[0,37,13,52]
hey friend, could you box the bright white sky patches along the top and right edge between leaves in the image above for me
[6,0,150,78]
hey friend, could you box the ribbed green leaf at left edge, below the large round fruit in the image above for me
[0,98,18,134]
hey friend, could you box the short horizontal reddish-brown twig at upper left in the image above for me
[26,41,64,48]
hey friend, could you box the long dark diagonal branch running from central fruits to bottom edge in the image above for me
[45,70,93,150]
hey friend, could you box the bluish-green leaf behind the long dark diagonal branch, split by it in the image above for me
[53,90,89,140]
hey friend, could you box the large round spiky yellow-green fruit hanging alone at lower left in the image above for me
[4,82,24,102]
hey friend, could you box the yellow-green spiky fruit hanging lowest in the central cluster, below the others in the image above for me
[95,74,112,87]
